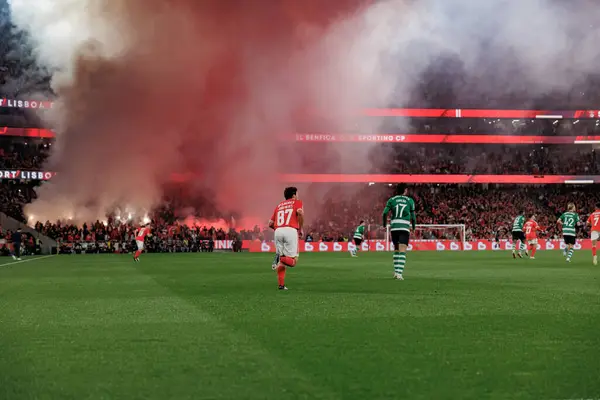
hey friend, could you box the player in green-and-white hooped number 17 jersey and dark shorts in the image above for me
[383,184,417,280]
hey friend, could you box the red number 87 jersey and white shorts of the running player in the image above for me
[271,199,302,257]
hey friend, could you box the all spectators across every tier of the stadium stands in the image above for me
[0,2,600,252]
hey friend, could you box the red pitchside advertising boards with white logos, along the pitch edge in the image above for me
[242,239,592,253]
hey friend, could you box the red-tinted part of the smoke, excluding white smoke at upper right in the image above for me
[28,0,380,220]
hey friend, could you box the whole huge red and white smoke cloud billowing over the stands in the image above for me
[11,0,600,225]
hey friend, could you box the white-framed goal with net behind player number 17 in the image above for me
[370,224,467,250]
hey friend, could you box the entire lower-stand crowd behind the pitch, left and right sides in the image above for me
[2,180,600,253]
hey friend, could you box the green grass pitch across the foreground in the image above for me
[0,251,600,400]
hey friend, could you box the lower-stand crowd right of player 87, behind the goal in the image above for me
[307,185,600,241]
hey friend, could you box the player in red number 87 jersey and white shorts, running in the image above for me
[269,187,304,290]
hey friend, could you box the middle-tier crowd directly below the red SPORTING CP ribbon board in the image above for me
[296,143,600,175]
